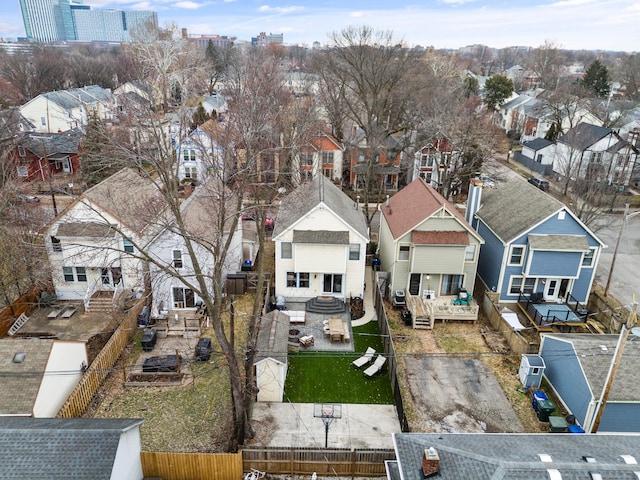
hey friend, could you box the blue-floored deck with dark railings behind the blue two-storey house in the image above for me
[518,293,598,333]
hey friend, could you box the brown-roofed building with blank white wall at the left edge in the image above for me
[0,338,88,418]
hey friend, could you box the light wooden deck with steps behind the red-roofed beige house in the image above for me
[407,292,480,329]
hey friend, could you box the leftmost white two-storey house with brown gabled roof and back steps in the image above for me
[44,168,165,310]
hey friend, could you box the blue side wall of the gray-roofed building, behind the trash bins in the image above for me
[540,337,593,425]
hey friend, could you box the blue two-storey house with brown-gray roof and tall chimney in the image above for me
[467,178,606,304]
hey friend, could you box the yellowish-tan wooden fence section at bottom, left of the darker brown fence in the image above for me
[140,452,244,480]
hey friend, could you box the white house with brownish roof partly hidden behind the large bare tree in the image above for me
[148,179,242,314]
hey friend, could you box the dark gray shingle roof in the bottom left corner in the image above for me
[0,417,143,480]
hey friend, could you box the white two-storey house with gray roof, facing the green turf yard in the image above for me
[272,175,369,301]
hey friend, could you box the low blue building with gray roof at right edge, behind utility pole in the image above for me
[540,334,640,432]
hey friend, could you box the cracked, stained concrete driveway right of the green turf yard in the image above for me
[405,355,524,433]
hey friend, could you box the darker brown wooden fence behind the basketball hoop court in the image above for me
[242,447,396,479]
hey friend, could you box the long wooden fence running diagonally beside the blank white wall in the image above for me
[56,297,145,418]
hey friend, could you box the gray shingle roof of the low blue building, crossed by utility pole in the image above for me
[544,333,640,402]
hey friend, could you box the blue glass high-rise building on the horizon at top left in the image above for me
[20,0,158,43]
